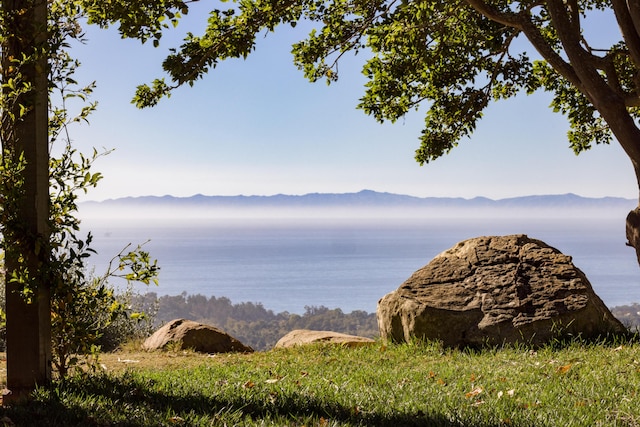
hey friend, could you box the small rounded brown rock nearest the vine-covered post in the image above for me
[142,319,253,353]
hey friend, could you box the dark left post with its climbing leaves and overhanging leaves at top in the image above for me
[0,0,200,388]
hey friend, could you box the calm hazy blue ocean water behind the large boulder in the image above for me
[83,217,640,313]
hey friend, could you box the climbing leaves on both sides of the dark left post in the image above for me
[1,1,158,377]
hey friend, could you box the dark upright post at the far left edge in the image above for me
[2,0,51,402]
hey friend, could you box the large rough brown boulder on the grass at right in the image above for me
[377,234,626,347]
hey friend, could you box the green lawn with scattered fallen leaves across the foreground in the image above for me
[0,341,640,427]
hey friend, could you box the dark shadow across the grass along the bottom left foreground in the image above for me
[0,375,516,427]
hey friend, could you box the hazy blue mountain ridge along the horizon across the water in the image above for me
[82,190,637,209]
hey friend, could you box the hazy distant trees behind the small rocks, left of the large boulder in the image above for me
[134,292,379,350]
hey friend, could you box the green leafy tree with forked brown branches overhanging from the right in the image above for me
[134,0,640,262]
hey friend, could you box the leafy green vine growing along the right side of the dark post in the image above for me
[49,9,158,377]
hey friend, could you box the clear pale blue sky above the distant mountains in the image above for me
[71,1,638,200]
